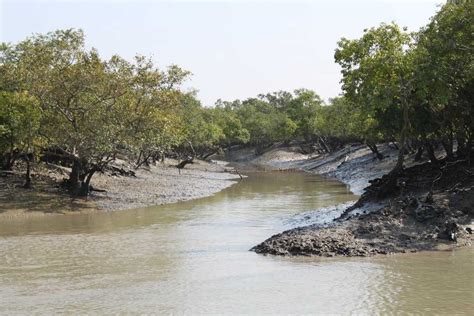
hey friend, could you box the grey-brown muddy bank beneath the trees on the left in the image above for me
[0,160,240,219]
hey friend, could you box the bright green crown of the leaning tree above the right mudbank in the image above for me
[335,24,412,145]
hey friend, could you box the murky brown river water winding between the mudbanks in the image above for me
[0,173,474,315]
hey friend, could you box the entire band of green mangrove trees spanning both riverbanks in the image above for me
[0,1,474,195]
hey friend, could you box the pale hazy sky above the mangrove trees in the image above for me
[0,0,445,105]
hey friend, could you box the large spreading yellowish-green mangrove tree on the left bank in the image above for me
[0,30,189,193]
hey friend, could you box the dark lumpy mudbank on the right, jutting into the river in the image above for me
[246,145,474,257]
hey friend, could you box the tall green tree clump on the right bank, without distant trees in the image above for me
[335,1,474,168]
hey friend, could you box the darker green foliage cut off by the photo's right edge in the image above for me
[414,1,474,149]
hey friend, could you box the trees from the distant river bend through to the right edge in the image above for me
[188,1,474,171]
